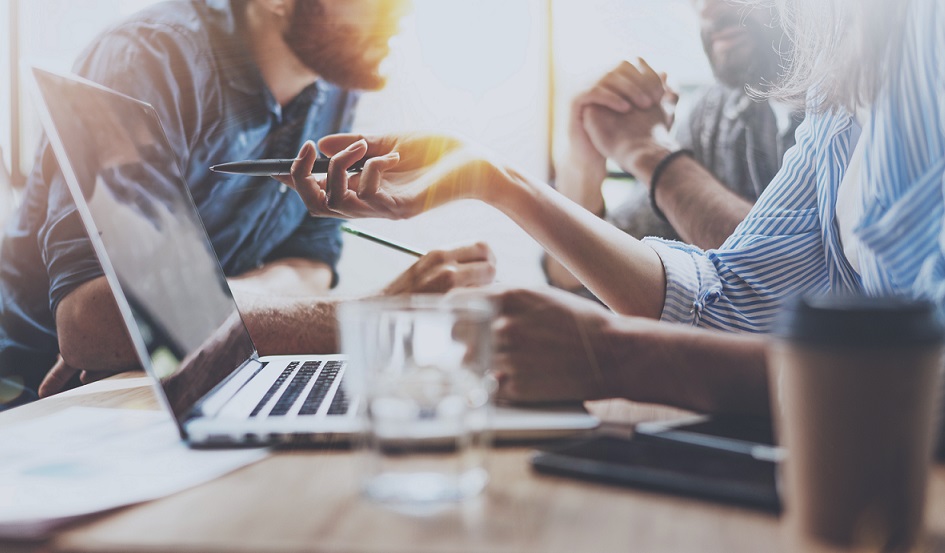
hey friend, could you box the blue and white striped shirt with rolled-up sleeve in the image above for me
[646,0,945,332]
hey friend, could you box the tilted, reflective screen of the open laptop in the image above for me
[33,69,255,423]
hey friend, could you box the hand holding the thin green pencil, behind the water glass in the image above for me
[383,242,495,296]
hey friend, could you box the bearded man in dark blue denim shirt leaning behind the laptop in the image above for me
[0,0,494,410]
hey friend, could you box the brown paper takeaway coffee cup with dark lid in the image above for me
[768,297,945,551]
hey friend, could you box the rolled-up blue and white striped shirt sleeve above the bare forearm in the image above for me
[645,116,830,332]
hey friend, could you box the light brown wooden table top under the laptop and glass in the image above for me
[0,373,945,553]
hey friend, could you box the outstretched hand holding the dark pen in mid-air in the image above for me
[279,134,496,219]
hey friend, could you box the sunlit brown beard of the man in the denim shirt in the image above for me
[283,0,395,90]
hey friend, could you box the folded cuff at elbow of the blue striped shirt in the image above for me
[643,238,722,326]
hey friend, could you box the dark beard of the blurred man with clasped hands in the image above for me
[701,8,790,89]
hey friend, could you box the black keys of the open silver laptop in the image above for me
[249,361,348,417]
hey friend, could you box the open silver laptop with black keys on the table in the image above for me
[33,68,599,447]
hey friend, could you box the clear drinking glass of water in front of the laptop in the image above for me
[338,296,495,504]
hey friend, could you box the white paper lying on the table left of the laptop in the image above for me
[0,407,268,538]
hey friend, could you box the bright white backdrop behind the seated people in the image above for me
[0,0,710,294]
